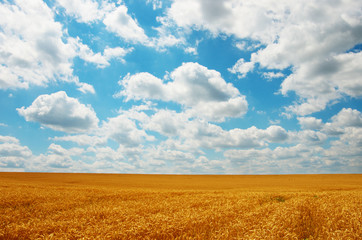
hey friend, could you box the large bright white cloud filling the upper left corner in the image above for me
[0,0,98,93]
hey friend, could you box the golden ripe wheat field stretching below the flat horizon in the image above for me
[0,173,362,239]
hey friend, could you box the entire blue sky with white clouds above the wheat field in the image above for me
[0,0,362,174]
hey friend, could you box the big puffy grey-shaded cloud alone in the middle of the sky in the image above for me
[117,62,248,121]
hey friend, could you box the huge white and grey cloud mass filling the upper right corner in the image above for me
[167,0,362,115]
